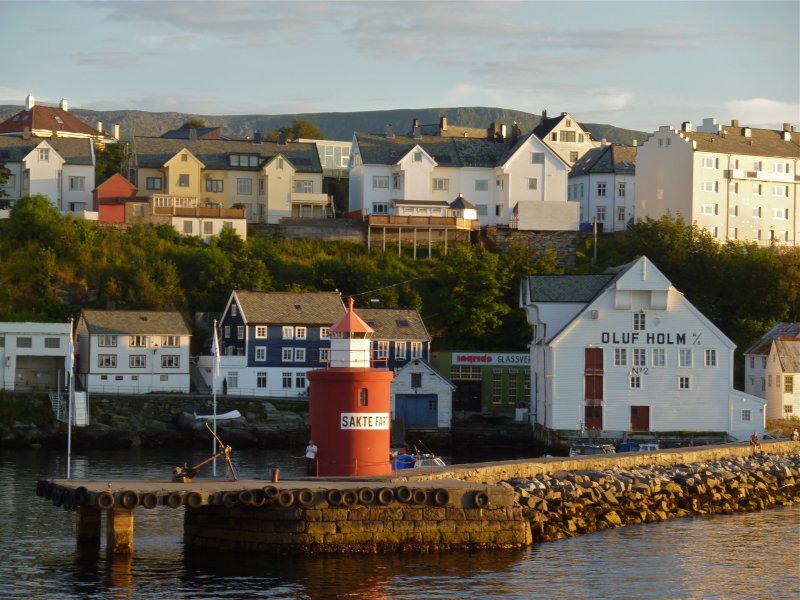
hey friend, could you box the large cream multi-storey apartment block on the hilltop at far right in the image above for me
[636,119,800,246]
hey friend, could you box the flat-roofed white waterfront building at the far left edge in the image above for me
[0,323,72,391]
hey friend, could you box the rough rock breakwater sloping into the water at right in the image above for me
[503,450,800,543]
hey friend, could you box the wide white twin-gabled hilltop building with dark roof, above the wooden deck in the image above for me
[349,132,578,231]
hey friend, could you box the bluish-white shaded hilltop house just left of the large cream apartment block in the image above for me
[567,144,637,232]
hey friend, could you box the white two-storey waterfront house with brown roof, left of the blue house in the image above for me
[76,310,191,394]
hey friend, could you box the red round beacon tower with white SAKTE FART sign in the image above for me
[307,298,394,476]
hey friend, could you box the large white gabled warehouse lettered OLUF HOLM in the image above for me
[520,257,766,439]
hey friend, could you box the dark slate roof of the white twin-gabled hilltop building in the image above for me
[356,133,532,168]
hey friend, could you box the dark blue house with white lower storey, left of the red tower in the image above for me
[209,290,346,397]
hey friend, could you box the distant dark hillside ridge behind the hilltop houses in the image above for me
[0,104,650,144]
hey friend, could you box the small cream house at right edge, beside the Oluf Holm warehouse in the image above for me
[744,323,800,419]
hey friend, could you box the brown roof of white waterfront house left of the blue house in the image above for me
[81,309,192,335]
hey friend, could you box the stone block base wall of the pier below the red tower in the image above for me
[184,485,531,554]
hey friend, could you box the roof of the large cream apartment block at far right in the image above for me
[680,125,800,158]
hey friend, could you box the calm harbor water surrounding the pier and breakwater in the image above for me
[0,450,800,599]
